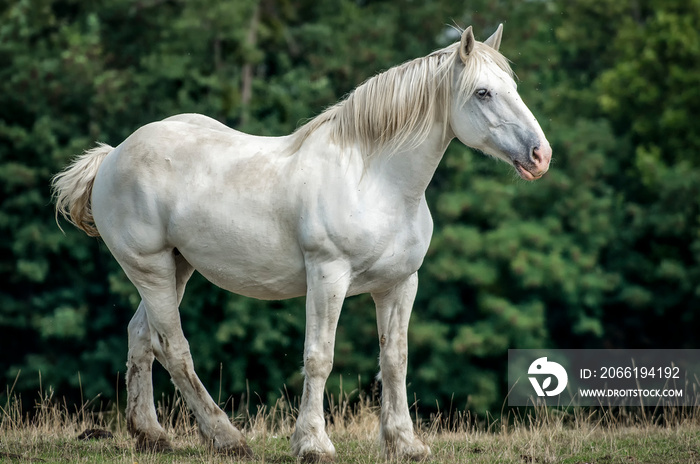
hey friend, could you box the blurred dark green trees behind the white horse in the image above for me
[0,0,700,413]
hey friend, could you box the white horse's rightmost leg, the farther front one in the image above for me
[372,274,430,460]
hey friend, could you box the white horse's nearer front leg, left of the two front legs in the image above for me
[291,263,349,462]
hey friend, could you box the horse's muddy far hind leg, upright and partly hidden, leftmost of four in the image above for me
[126,252,194,451]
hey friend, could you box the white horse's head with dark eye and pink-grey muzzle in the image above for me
[450,25,552,180]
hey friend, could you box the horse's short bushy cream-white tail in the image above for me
[51,143,114,237]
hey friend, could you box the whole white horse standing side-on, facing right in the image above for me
[53,26,551,461]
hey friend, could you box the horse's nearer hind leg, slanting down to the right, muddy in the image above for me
[120,251,251,455]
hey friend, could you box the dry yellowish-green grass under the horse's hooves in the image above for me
[0,388,700,464]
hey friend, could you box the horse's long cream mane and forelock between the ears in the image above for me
[293,42,513,158]
